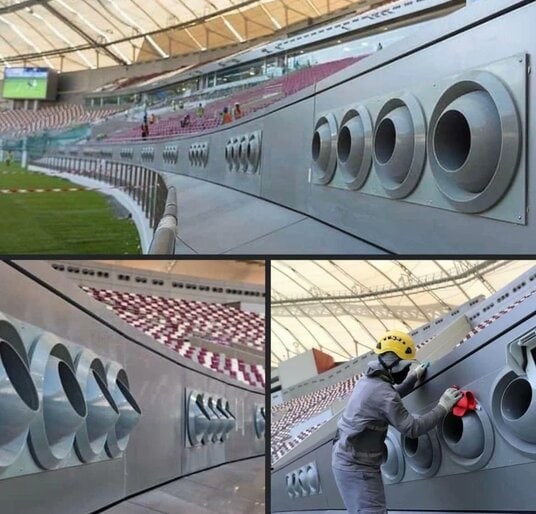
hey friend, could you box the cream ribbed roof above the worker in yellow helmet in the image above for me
[271,260,536,367]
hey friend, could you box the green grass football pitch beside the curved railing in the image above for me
[0,163,141,255]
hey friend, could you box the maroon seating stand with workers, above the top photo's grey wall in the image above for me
[109,56,364,141]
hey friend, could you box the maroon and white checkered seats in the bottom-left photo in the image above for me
[82,286,265,388]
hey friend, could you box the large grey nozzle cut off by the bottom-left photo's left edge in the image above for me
[0,339,39,468]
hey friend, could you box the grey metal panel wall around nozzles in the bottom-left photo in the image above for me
[0,261,264,514]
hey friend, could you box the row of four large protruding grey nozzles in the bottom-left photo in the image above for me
[0,320,141,469]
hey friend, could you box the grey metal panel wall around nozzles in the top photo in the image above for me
[66,0,536,253]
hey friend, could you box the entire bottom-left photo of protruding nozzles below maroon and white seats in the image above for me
[0,259,266,514]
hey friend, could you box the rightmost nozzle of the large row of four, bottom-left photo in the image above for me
[105,363,141,458]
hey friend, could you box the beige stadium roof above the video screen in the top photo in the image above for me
[0,0,390,71]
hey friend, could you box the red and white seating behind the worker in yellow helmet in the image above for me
[271,290,536,464]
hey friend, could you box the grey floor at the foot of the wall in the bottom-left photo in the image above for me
[100,457,265,514]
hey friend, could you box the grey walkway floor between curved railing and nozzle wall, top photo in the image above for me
[161,173,383,255]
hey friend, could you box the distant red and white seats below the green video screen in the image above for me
[0,104,119,136]
